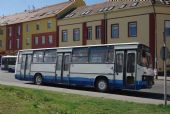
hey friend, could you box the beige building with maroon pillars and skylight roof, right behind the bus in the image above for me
[58,0,170,74]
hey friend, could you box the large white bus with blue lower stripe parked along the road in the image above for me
[15,43,154,92]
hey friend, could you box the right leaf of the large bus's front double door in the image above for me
[126,50,136,89]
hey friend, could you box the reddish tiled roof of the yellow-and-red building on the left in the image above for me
[0,0,75,26]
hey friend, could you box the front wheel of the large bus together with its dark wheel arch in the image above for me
[94,76,109,92]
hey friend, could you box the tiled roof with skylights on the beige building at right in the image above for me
[65,0,168,18]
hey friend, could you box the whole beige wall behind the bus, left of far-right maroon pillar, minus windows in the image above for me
[58,7,152,46]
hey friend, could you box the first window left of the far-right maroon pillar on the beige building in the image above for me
[128,22,137,37]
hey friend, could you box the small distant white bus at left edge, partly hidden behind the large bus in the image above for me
[1,55,17,72]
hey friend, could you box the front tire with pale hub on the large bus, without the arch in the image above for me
[95,78,108,92]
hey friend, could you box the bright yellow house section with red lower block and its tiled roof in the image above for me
[23,0,85,49]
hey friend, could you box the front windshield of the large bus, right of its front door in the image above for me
[138,50,152,68]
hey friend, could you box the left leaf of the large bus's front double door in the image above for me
[114,51,125,89]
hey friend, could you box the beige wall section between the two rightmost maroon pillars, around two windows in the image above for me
[107,14,149,46]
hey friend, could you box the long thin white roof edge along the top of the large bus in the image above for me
[20,42,140,51]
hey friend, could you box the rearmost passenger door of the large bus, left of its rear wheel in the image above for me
[21,54,32,80]
